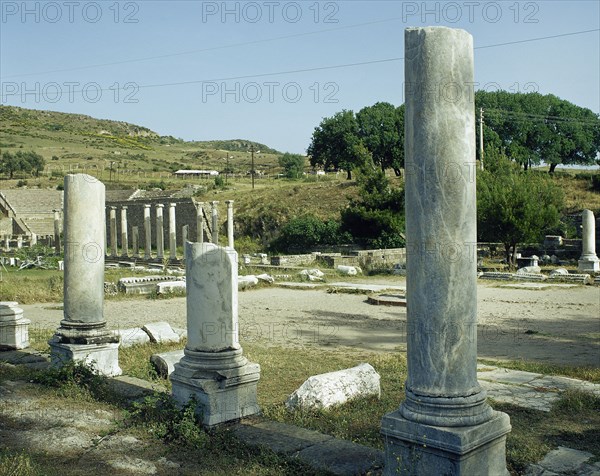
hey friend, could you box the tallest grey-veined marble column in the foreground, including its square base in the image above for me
[381,27,510,475]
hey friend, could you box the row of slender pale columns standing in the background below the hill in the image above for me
[103,200,234,259]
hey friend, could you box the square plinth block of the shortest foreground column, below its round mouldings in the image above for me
[169,362,260,427]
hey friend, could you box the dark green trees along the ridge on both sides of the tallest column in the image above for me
[307,91,600,179]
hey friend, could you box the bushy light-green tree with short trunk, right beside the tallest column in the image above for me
[477,157,564,266]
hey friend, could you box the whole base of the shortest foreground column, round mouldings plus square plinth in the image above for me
[169,349,260,427]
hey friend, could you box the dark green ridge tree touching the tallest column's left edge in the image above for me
[356,102,404,176]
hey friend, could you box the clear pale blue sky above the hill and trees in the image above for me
[0,0,600,153]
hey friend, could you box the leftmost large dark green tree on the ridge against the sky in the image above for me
[307,110,365,180]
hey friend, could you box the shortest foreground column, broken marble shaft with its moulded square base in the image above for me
[170,242,260,426]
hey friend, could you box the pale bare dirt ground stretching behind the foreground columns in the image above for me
[21,279,600,366]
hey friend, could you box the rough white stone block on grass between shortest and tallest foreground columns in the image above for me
[285,363,381,409]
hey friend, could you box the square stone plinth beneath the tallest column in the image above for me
[381,410,511,476]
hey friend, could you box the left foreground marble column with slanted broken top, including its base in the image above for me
[49,174,121,375]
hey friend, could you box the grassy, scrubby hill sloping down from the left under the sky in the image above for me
[0,105,280,178]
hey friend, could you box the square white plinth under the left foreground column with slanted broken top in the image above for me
[48,337,122,377]
